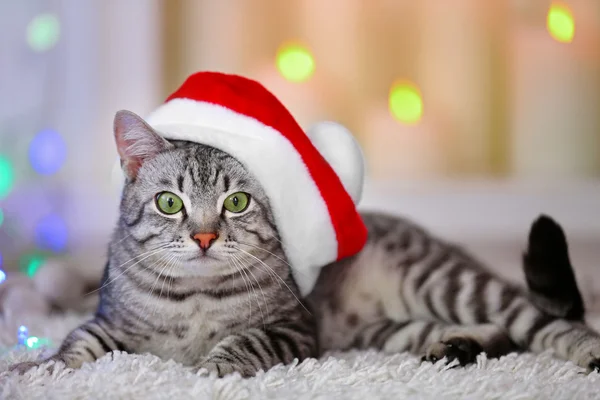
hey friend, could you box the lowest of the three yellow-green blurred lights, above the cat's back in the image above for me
[389,82,423,125]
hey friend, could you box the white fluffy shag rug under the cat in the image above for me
[0,315,600,400]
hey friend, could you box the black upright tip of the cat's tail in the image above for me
[523,215,585,321]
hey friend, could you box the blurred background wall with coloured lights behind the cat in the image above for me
[0,0,600,300]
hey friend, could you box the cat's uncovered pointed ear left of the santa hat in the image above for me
[114,110,172,180]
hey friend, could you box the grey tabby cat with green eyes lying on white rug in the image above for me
[8,111,600,377]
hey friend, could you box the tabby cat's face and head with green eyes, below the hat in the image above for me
[114,111,280,276]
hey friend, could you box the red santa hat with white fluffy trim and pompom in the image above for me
[147,72,367,295]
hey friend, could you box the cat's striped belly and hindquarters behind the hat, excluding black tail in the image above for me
[308,214,600,368]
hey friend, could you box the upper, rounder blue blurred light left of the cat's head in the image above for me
[29,129,67,175]
